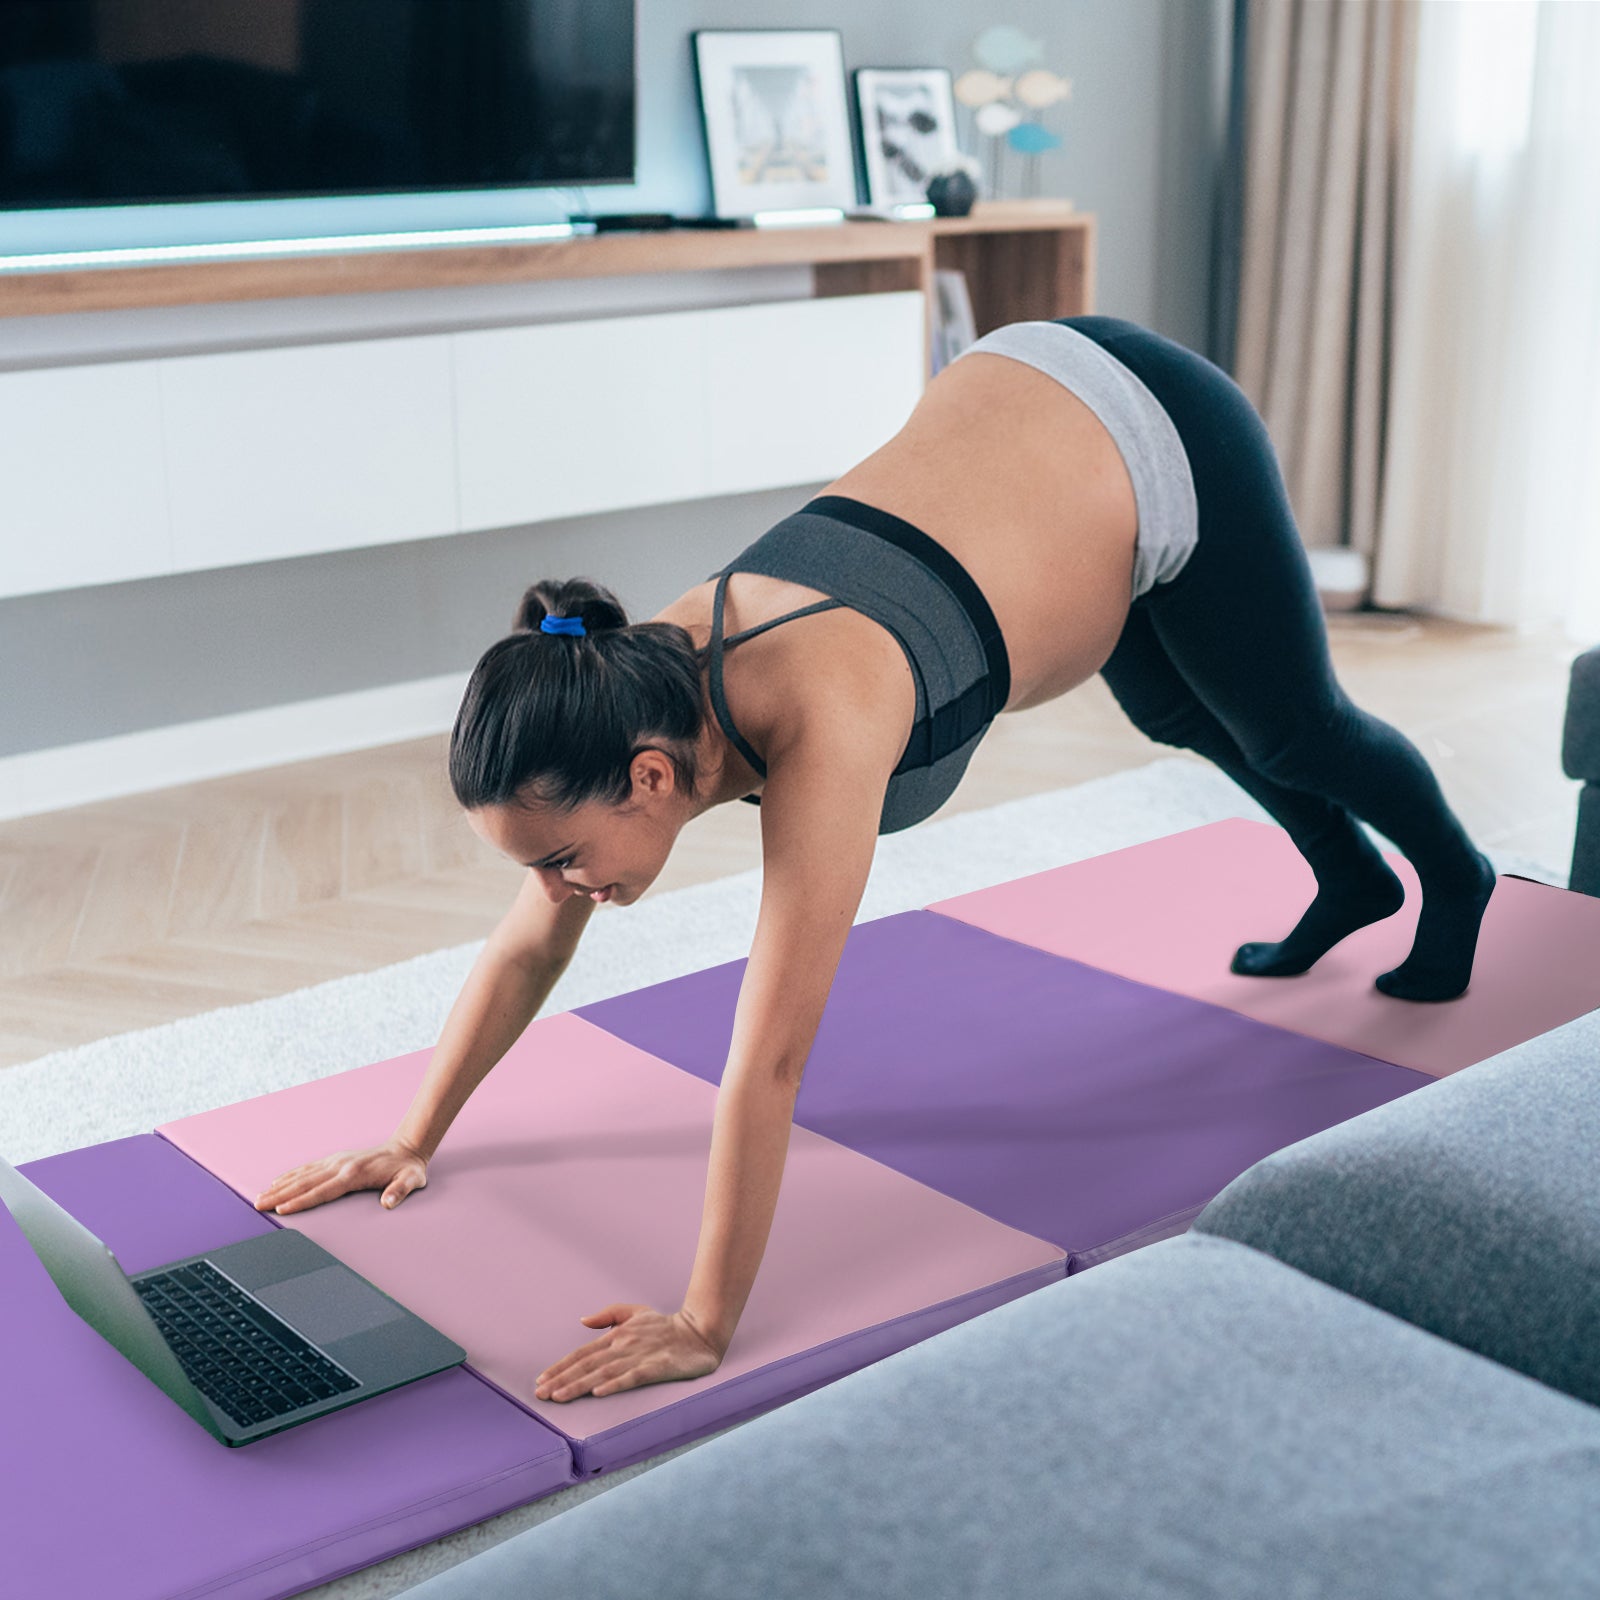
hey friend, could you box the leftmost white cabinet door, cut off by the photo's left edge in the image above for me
[0,362,171,595]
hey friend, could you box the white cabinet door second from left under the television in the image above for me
[160,334,461,570]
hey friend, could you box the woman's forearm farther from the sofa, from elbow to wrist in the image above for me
[395,944,568,1160]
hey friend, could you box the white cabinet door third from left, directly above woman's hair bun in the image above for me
[453,312,717,528]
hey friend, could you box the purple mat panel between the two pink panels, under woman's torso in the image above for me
[578,910,1432,1272]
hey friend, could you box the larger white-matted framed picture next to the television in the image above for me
[690,27,856,216]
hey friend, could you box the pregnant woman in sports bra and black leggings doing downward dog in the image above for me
[256,317,1494,1400]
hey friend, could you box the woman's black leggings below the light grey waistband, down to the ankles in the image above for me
[1059,317,1477,890]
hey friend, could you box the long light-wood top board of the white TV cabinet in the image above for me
[0,200,1094,317]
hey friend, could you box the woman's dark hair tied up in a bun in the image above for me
[450,578,706,811]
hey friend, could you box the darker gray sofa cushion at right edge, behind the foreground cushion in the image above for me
[1194,1011,1600,1403]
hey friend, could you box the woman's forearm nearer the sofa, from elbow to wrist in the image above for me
[683,1069,800,1354]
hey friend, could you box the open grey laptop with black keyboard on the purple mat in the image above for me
[0,1157,467,1445]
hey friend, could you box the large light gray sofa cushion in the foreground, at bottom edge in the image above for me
[393,1234,1600,1600]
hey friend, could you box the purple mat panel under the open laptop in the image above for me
[0,1134,574,1600]
